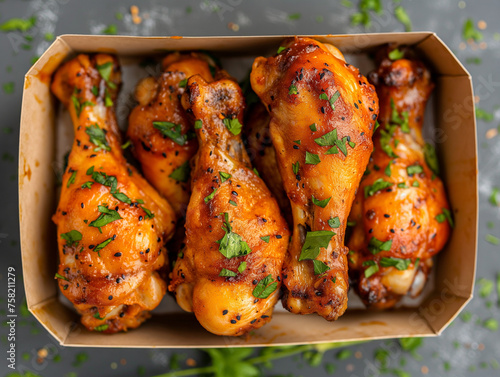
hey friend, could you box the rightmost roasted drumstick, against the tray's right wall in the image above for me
[348,49,452,308]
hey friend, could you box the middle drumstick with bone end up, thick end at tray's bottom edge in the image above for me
[169,76,290,336]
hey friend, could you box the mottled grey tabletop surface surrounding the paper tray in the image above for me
[0,0,500,377]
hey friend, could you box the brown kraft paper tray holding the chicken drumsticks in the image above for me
[19,32,478,348]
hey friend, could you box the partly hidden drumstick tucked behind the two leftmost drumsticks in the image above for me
[127,52,213,217]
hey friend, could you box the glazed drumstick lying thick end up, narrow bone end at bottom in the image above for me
[251,38,378,320]
